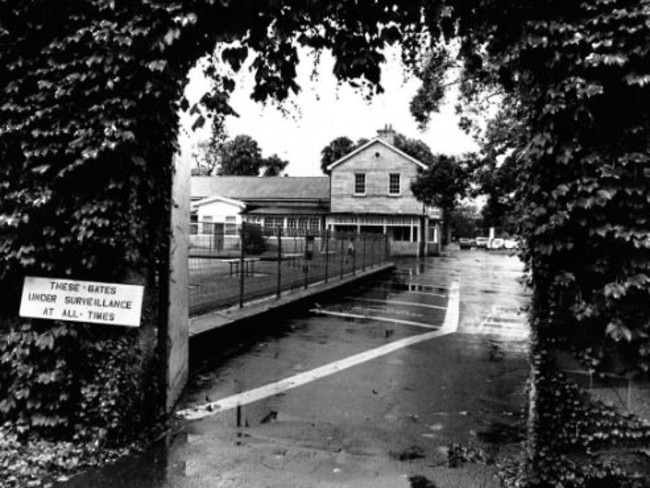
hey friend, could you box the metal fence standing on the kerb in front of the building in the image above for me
[189,223,389,315]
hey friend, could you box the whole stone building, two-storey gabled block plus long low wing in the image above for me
[191,127,441,256]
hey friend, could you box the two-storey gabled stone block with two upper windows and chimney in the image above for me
[327,126,441,256]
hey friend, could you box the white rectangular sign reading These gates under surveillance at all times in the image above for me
[19,276,144,327]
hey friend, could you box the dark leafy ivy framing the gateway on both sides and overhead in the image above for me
[0,0,650,486]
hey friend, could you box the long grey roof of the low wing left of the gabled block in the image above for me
[191,176,330,201]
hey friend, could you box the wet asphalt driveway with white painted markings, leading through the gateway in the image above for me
[57,250,528,488]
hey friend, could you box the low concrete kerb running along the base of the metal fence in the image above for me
[188,262,395,338]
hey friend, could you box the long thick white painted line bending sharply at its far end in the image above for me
[176,283,460,420]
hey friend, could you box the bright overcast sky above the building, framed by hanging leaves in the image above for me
[181,46,476,176]
